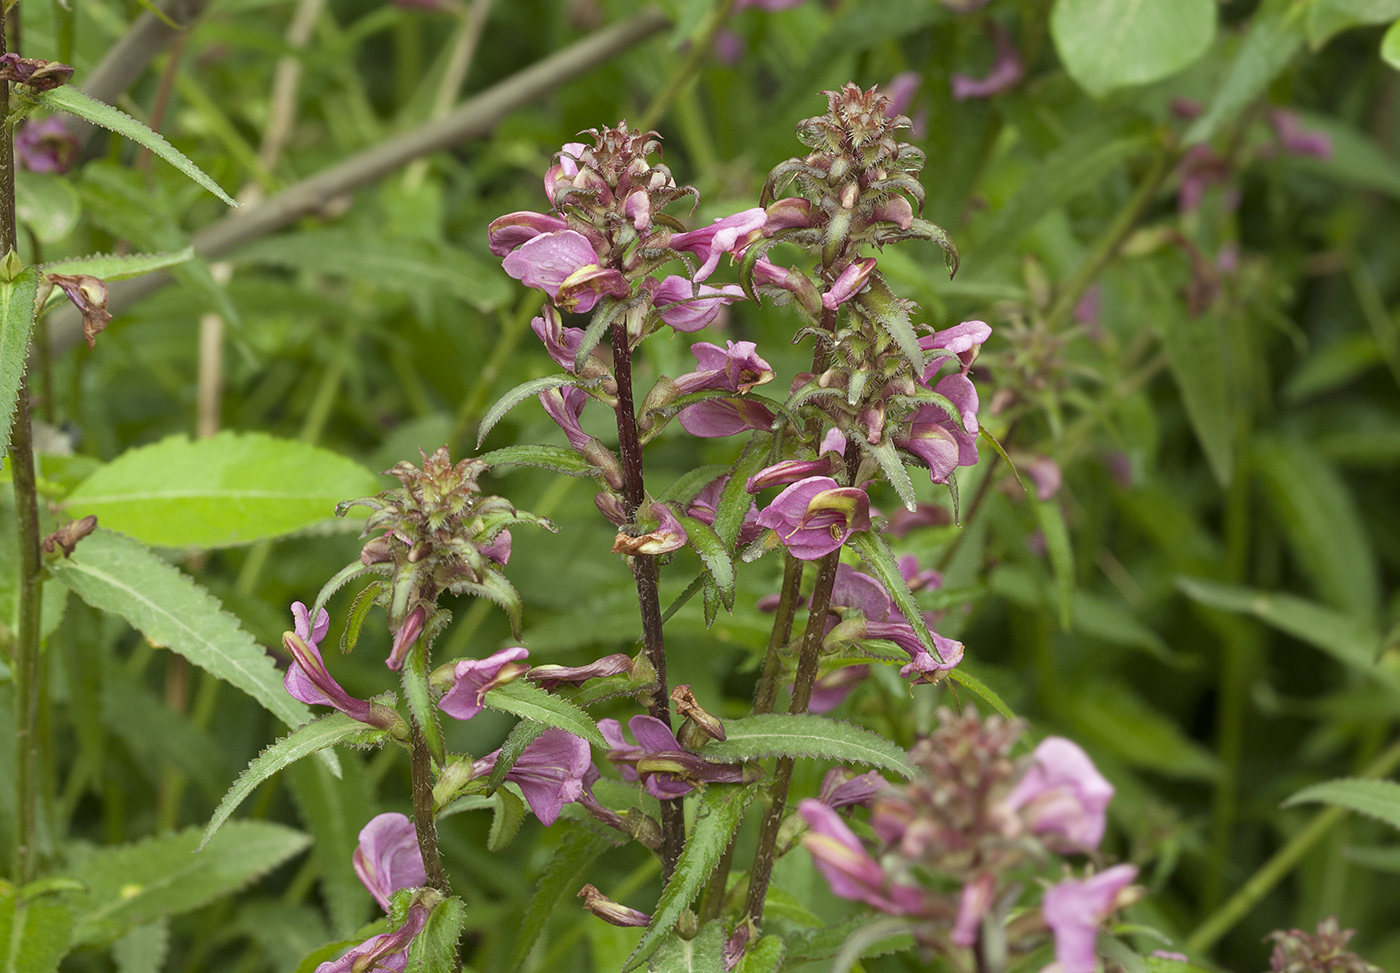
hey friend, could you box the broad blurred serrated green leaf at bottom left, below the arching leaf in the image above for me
[73,820,311,945]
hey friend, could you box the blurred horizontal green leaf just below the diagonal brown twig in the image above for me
[234,228,511,311]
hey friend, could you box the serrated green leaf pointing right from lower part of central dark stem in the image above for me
[704,713,914,778]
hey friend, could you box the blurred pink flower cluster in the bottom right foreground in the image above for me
[799,710,1137,973]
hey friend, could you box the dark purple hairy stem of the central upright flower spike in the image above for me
[612,315,686,881]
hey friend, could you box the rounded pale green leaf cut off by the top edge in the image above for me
[1050,0,1215,98]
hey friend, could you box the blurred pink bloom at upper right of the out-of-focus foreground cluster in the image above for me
[1005,736,1113,851]
